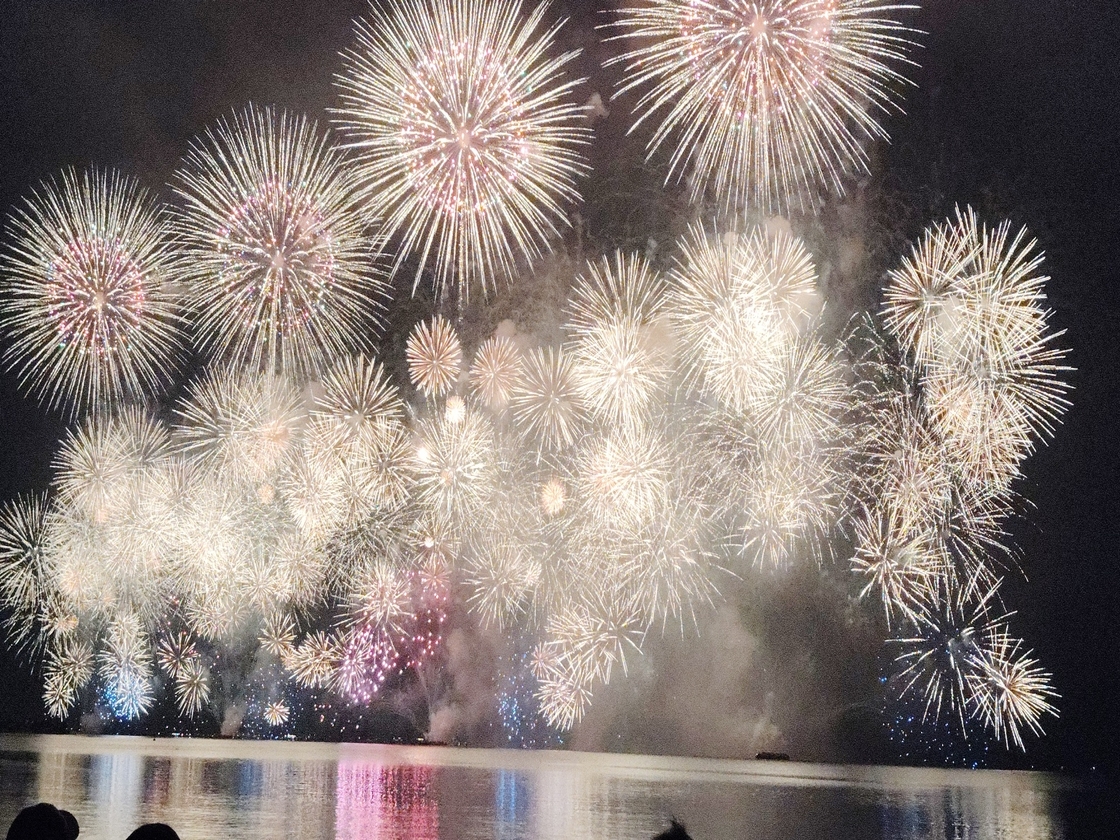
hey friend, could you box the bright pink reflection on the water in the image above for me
[335,760,439,840]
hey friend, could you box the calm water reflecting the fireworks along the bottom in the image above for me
[0,736,1111,840]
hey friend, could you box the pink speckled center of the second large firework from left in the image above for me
[218,181,335,328]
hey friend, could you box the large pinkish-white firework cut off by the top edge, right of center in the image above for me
[613,0,914,211]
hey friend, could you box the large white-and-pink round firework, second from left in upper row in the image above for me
[176,108,381,374]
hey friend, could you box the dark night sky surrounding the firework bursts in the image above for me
[0,0,1120,767]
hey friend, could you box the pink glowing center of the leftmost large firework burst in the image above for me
[46,239,147,355]
